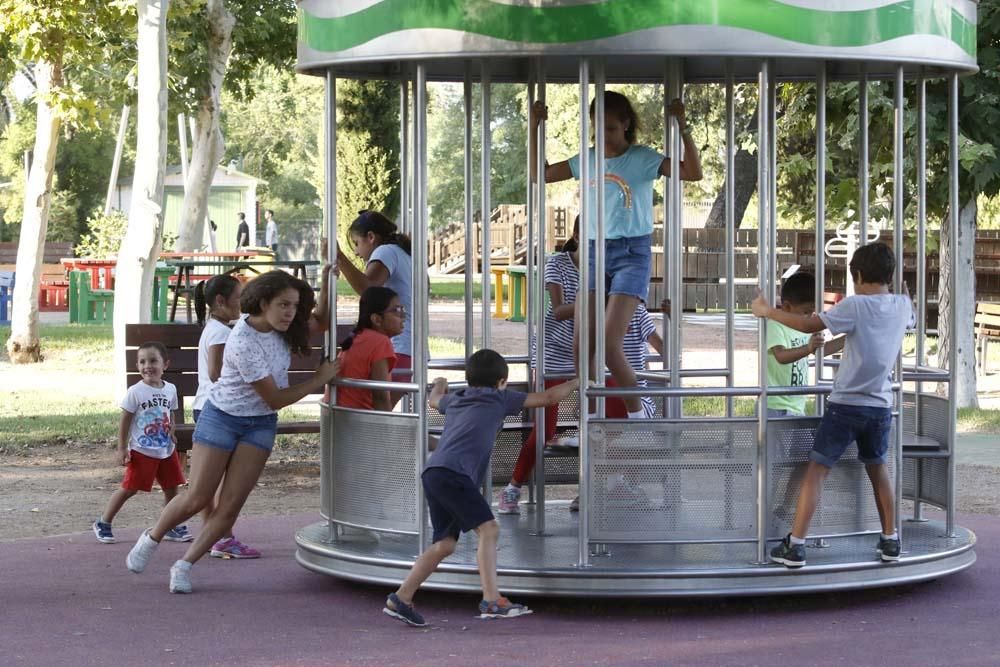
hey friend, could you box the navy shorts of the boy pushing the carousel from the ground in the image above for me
[421,468,493,542]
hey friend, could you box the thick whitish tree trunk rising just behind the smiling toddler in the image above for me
[114,0,170,389]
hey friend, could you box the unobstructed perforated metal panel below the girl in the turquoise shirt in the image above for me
[588,420,757,542]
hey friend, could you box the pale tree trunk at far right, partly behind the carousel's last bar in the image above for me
[938,197,979,408]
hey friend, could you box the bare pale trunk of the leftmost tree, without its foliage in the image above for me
[7,61,62,364]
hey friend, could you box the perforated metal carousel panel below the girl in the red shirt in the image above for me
[321,407,419,532]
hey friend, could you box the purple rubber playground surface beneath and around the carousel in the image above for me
[0,514,1000,667]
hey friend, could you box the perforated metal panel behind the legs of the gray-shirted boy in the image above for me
[767,417,896,539]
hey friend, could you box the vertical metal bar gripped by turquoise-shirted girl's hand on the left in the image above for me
[528,58,552,535]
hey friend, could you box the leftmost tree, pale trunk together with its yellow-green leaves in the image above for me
[0,0,128,363]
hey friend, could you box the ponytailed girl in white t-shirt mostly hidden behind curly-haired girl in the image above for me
[193,274,260,558]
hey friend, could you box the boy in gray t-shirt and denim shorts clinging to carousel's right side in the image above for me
[751,243,914,567]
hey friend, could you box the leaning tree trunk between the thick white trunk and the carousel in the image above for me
[176,0,236,252]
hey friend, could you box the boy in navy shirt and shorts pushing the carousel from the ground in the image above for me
[382,349,579,627]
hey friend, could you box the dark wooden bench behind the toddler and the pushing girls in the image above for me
[125,324,353,451]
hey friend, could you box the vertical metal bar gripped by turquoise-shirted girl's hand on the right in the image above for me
[663,58,684,419]
